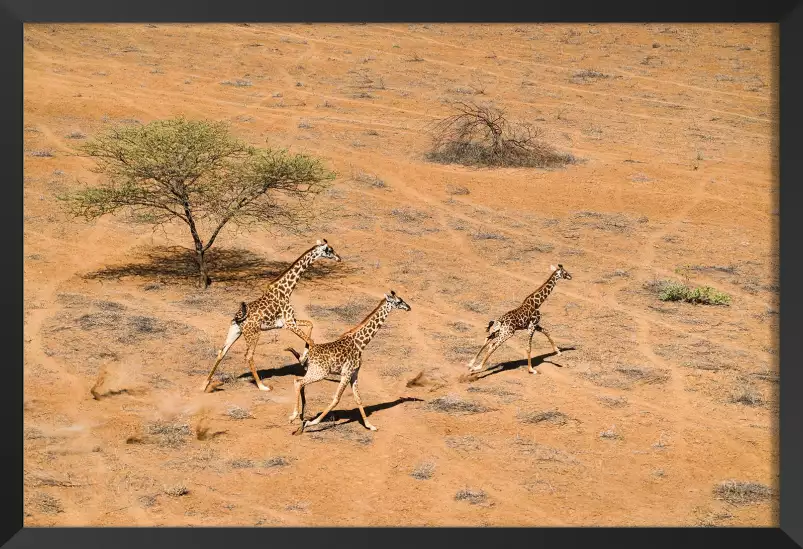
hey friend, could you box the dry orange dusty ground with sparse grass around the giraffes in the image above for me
[24,24,778,526]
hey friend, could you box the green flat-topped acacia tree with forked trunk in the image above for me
[59,117,335,288]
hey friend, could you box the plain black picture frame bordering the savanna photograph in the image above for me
[0,0,803,549]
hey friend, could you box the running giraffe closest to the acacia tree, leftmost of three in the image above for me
[202,239,340,392]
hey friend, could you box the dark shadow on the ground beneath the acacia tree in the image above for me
[84,246,357,284]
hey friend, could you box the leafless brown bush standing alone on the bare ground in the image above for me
[426,101,576,168]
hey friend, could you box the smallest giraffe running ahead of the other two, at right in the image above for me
[468,265,572,374]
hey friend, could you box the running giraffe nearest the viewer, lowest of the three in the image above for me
[285,290,410,434]
